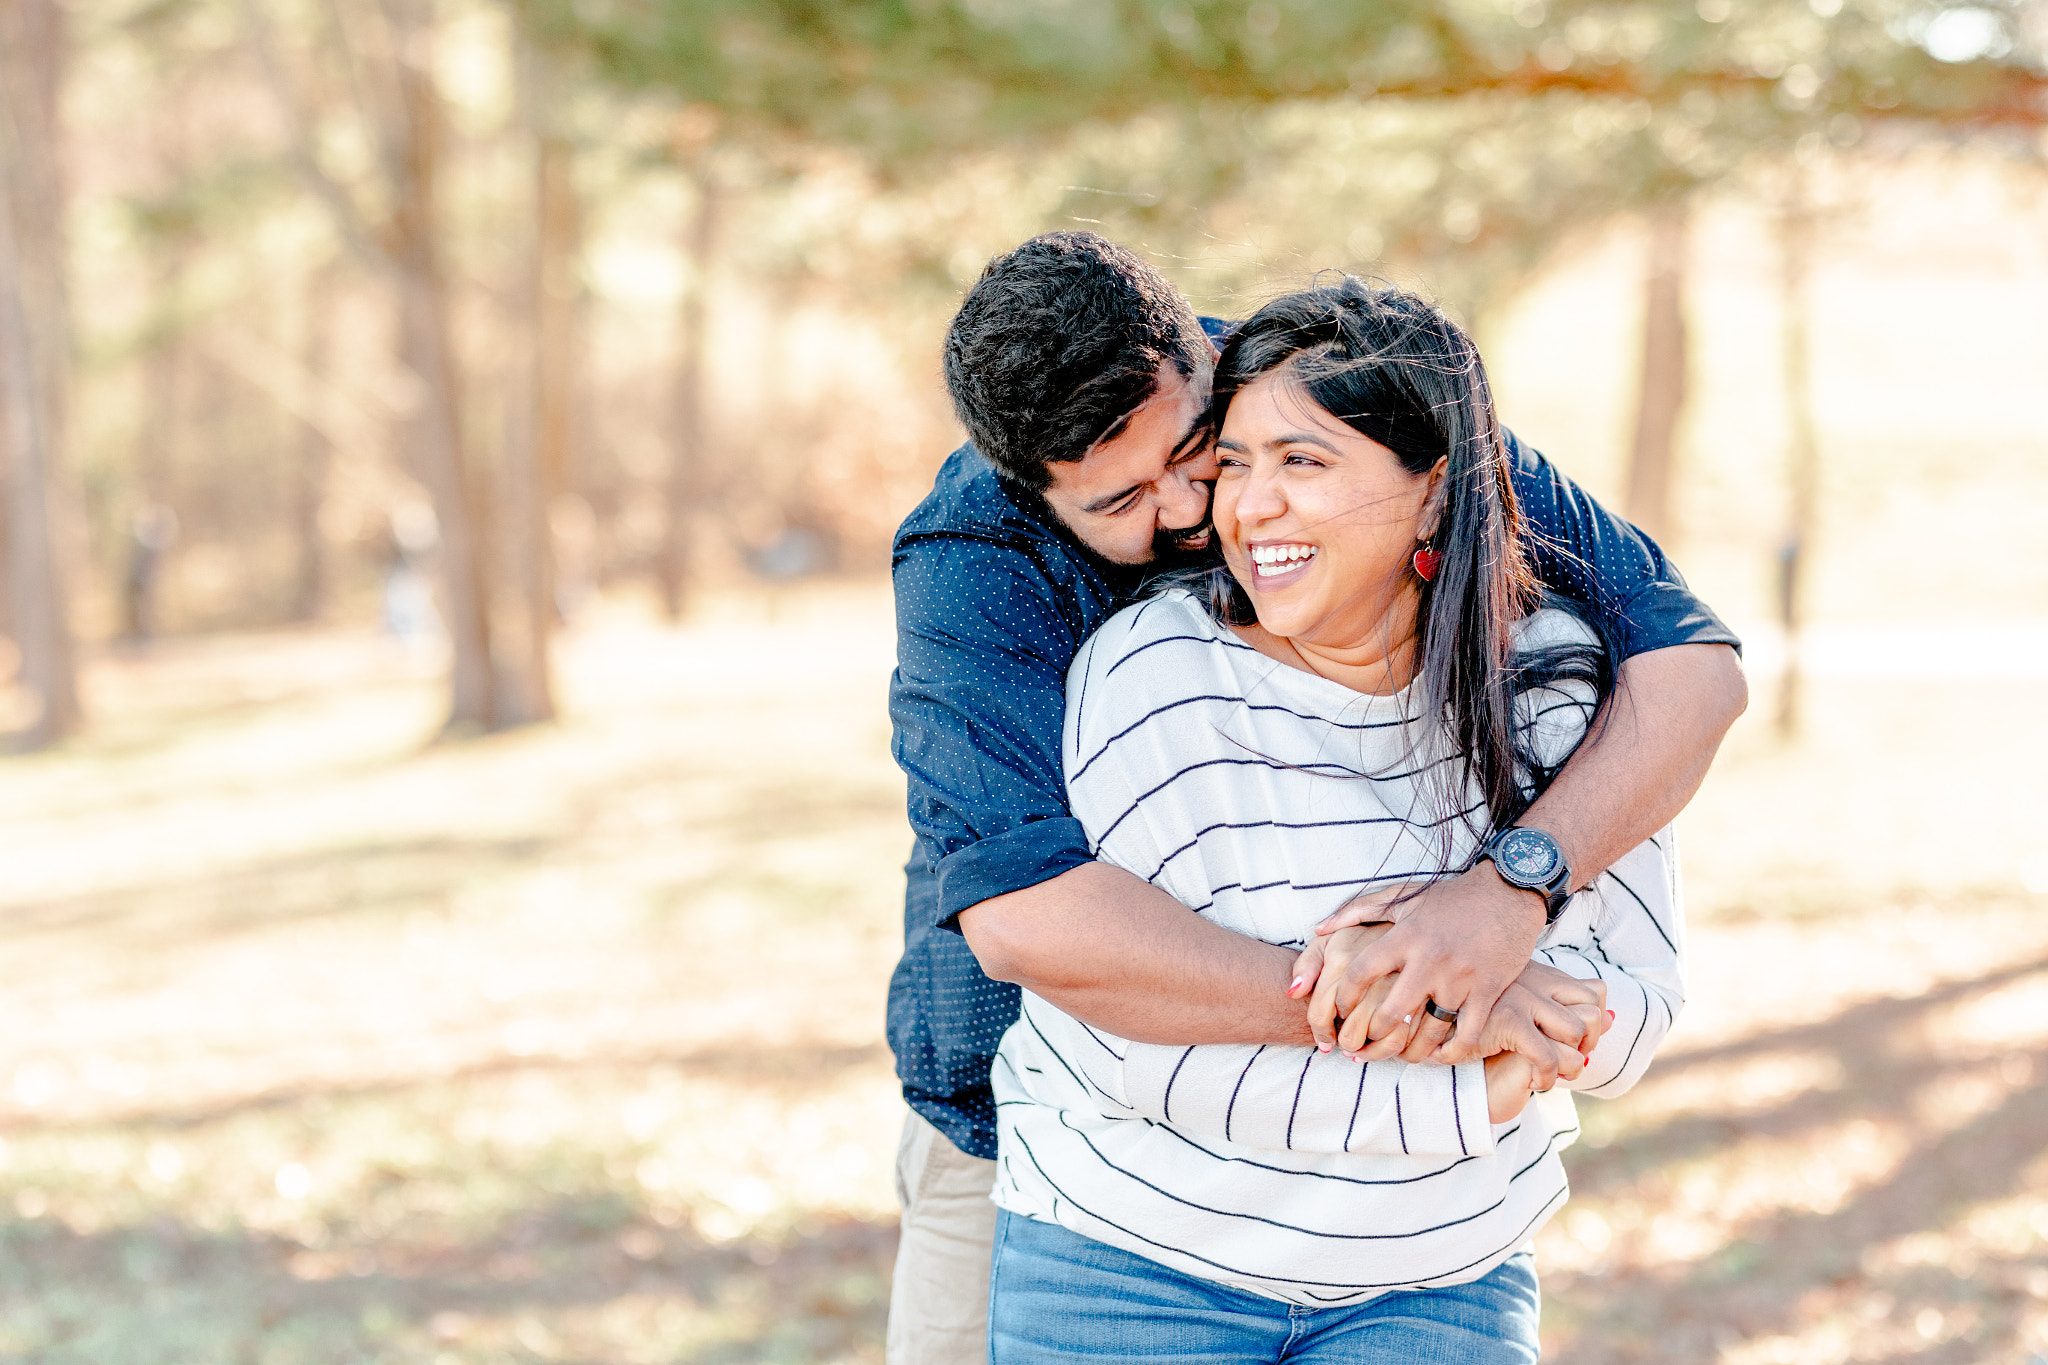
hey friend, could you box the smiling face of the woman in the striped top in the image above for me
[1214,368,1442,651]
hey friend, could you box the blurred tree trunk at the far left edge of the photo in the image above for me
[0,0,82,747]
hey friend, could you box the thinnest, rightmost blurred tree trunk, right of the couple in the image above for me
[1778,166,1821,739]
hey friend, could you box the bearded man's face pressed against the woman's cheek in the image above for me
[1044,362,1217,565]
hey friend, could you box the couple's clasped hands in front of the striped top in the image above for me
[1288,874,1612,1124]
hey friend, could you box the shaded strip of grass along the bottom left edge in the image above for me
[0,1191,895,1365]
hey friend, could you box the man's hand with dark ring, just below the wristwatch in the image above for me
[1296,862,1544,1062]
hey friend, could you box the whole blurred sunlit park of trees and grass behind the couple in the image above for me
[0,0,2048,1365]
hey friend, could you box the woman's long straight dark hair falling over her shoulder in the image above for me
[1198,276,1616,835]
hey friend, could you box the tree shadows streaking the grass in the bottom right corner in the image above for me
[1554,958,2048,1365]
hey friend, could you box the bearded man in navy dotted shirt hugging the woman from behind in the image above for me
[889,233,1745,1365]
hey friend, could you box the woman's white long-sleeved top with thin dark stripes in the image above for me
[993,591,1683,1306]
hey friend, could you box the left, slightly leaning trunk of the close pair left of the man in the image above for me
[387,0,500,731]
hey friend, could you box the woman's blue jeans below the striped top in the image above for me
[989,1212,1540,1365]
